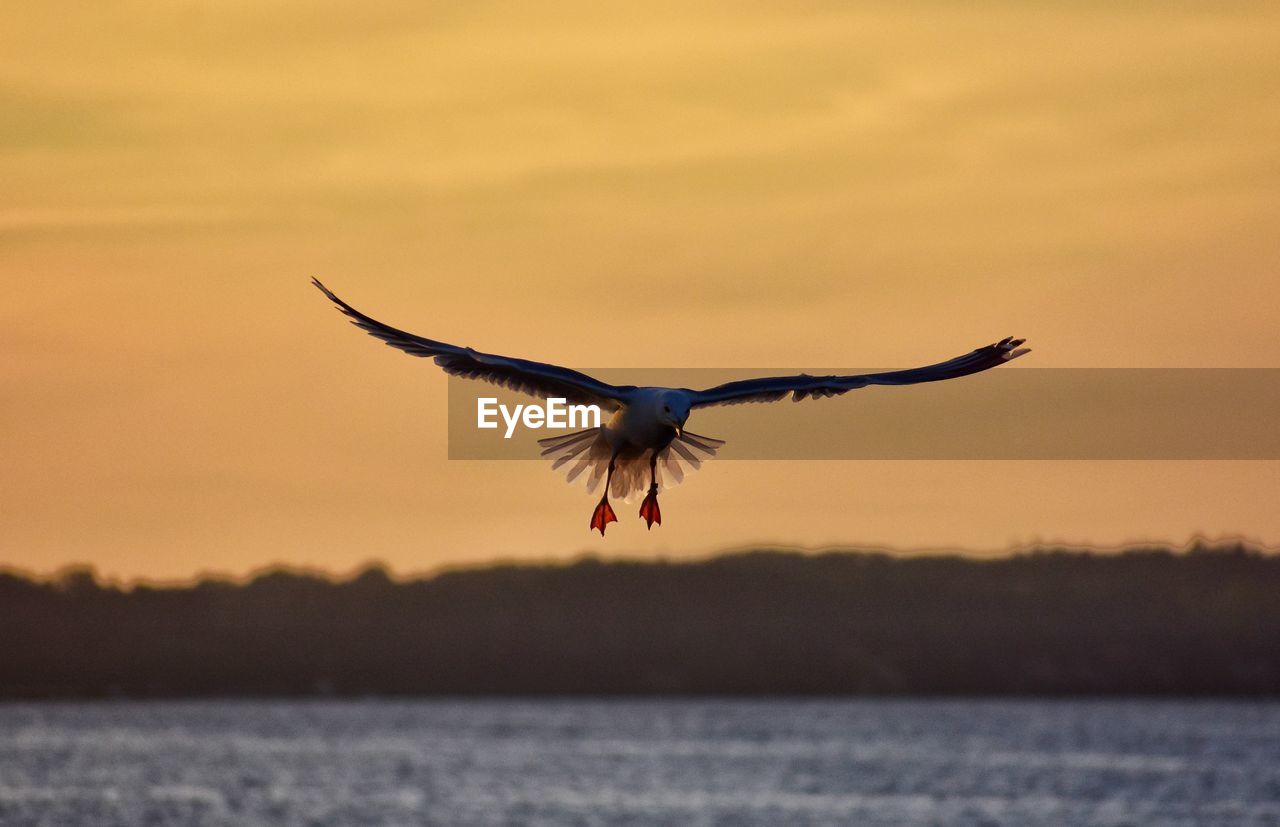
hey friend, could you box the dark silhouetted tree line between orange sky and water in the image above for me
[0,545,1280,698]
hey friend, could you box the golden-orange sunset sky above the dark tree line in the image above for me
[0,0,1280,577]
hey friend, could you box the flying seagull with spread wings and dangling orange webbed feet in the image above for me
[311,279,1030,536]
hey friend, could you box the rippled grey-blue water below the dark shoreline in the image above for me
[0,700,1280,826]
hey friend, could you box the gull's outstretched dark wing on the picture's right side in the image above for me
[692,338,1030,407]
